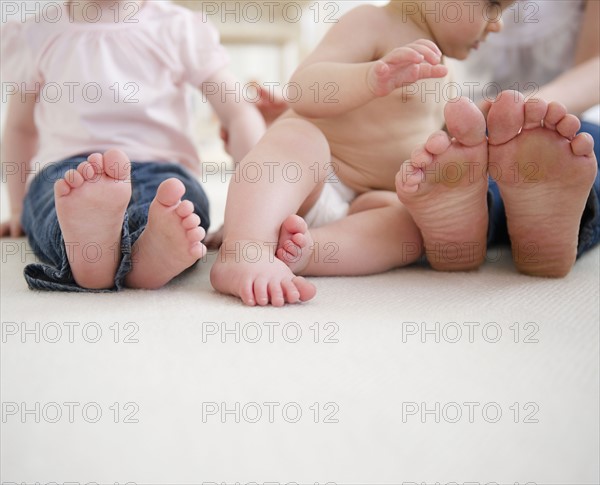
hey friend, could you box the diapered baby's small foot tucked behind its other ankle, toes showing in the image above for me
[275,215,313,274]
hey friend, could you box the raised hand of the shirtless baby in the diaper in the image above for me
[367,39,448,97]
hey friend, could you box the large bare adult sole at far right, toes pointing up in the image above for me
[487,91,597,277]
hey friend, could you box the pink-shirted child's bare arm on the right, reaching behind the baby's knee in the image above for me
[201,69,266,164]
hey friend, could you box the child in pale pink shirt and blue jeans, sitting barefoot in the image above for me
[2,0,265,291]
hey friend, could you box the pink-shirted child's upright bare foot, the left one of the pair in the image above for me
[54,150,131,289]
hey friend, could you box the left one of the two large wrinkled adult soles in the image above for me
[396,98,488,271]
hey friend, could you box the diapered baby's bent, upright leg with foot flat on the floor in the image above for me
[211,118,331,306]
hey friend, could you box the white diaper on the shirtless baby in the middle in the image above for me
[304,174,356,228]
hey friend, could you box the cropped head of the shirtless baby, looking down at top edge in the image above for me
[390,0,514,59]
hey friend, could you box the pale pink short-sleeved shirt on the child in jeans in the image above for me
[1,0,228,178]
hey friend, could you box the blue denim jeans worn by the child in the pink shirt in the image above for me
[21,155,210,292]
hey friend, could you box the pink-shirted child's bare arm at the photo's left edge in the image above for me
[0,93,38,237]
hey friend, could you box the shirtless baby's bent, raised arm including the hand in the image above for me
[291,6,447,118]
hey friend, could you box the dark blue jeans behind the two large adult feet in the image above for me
[488,122,600,257]
